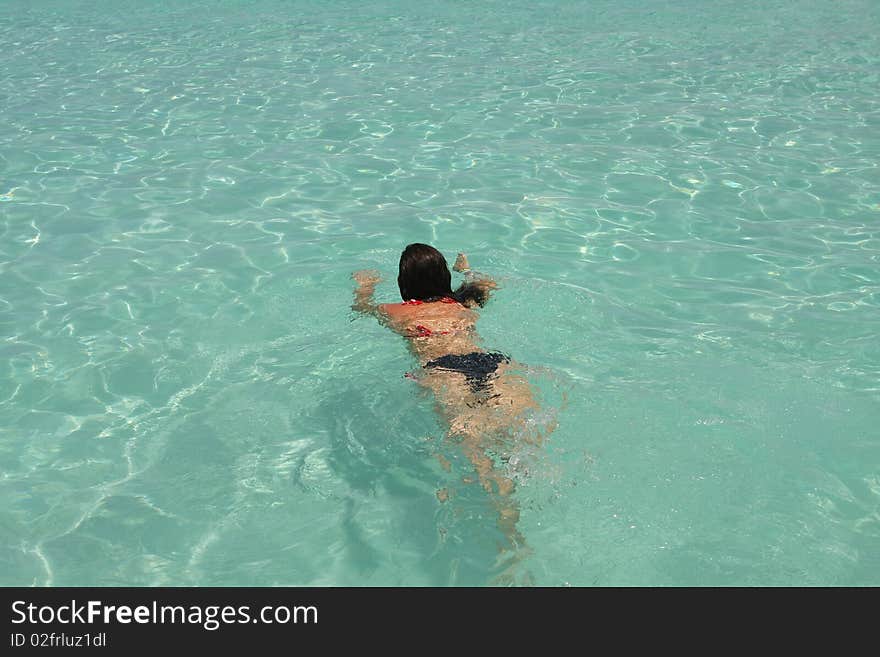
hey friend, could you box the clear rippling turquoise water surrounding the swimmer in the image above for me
[0,0,880,585]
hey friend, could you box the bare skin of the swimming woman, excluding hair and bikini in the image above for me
[352,254,542,548]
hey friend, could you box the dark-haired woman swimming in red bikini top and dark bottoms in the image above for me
[352,244,552,548]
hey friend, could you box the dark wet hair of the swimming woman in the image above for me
[397,243,489,306]
